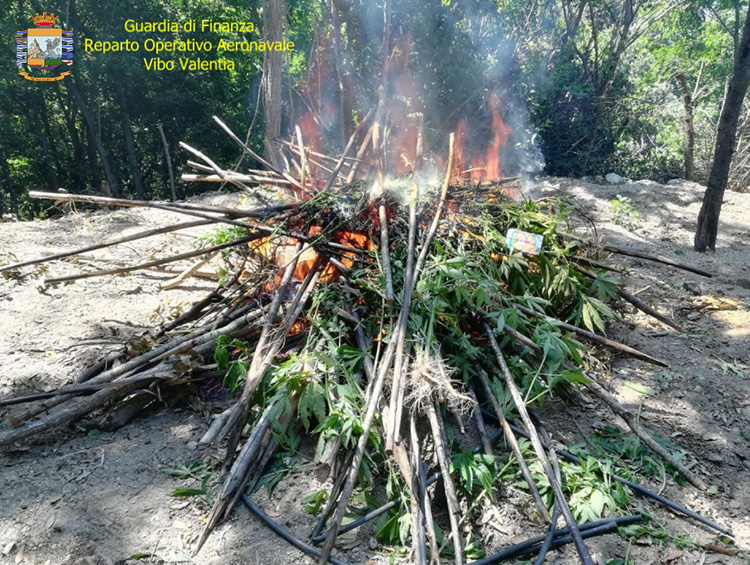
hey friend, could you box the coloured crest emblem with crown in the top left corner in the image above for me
[16,12,73,81]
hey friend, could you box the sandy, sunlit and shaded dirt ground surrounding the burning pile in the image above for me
[0,182,750,565]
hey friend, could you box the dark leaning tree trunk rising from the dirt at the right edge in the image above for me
[693,2,750,249]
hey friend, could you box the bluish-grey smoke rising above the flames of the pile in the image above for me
[294,0,544,180]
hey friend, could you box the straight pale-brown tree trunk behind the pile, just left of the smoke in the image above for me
[263,0,286,167]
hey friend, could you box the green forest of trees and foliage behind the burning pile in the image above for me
[0,0,750,218]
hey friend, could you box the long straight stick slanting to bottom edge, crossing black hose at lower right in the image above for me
[484,322,592,565]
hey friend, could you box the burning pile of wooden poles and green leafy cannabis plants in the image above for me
[0,111,728,563]
